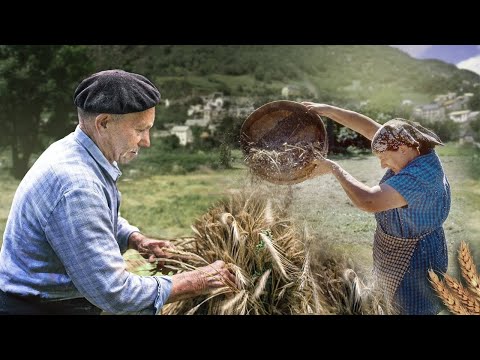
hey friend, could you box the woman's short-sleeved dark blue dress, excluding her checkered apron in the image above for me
[375,150,451,314]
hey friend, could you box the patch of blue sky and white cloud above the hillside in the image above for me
[391,45,480,75]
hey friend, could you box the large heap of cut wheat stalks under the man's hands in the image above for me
[124,188,396,315]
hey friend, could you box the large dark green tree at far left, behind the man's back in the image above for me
[0,45,91,179]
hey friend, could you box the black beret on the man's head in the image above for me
[73,69,160,114]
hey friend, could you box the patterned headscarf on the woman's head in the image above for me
[372,118,443,152]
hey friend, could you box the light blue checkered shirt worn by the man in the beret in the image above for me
[0,127,172,314]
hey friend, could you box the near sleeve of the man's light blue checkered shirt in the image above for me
[45,187,171,314]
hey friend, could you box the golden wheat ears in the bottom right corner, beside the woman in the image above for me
[428,241,480,315]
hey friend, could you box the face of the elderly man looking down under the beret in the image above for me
[105,107,155,164]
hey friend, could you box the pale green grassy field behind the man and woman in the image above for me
[0,144,480,278]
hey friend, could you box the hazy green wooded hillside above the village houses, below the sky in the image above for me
[139,45,480,111]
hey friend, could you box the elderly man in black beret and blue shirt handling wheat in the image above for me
[0,70,235,314]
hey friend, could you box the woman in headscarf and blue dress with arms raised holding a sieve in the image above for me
[302,102,450,315]
